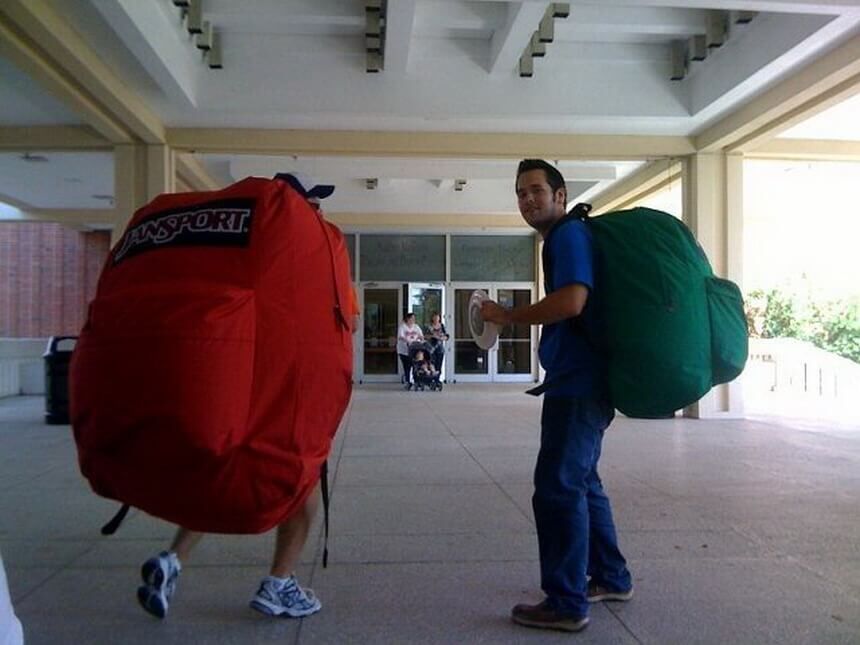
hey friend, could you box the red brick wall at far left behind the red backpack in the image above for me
[0,222,110,338]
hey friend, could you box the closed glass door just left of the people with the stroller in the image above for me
[359,282,402,382]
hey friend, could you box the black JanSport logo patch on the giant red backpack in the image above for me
[113,199,254,264]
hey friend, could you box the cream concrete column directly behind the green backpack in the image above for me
[682,153,743,419]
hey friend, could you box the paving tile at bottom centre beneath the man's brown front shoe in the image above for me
[299,563,636,645]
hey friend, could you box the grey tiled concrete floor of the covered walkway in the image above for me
[0,385,860,645]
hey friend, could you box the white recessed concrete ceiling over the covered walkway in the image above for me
[0,0,860,218]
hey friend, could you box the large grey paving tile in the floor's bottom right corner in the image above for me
[612,558,860,644]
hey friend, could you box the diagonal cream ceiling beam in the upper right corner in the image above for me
[695,35,860,153]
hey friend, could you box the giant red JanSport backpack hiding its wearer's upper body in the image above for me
[70,178,352,533]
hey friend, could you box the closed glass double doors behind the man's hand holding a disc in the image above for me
[451,283,537,382]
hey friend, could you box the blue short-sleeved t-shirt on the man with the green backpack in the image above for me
[538,219,607,397]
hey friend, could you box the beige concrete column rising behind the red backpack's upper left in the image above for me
[111,143,176,245]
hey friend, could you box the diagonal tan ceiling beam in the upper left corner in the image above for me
[0,0,164,143]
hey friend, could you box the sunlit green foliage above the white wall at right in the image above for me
[744,289,860,363]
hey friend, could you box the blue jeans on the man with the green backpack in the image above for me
[532,397,632,616]
